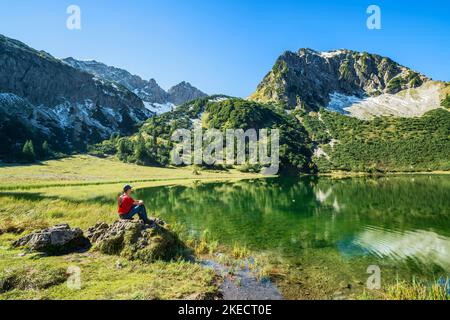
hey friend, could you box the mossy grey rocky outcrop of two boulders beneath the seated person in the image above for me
[13,218,180,262]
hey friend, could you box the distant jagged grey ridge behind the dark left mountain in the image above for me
[63,58,206,114]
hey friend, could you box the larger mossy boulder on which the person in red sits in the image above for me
[86,219,186,262]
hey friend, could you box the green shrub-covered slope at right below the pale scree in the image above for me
[303,109,450,172]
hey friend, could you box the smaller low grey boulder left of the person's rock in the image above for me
[13,224,90,254]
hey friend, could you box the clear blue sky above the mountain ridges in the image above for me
[0,0,450,97]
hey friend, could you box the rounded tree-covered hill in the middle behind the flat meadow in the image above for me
[91,96,312,172]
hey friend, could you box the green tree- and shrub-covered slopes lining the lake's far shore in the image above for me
[91,91,450,173]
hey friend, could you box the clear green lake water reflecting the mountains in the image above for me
[136,175,450,294]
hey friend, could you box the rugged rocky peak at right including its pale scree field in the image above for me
[250,48,442,116]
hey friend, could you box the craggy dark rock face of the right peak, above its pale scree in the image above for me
[251,49,430,110]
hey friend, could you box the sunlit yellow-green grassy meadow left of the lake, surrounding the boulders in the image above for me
[0,155,260,300]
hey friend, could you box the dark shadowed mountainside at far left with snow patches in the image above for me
[0,35,152,158]
